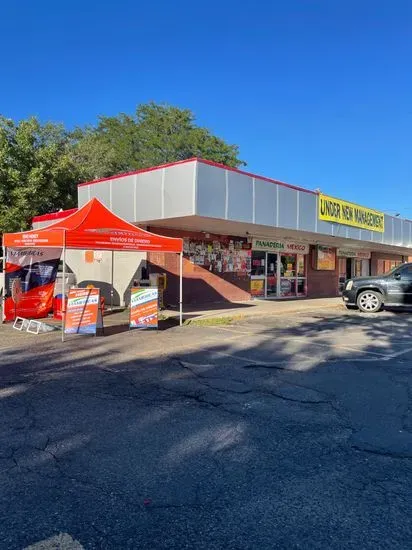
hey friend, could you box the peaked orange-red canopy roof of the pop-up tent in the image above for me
[3,198,183,252]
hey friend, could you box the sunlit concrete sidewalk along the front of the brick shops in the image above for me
[162,297,344,321]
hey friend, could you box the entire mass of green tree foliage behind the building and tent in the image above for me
[0,103,245,233]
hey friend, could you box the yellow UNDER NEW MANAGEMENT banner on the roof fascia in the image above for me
[319,195,385,233]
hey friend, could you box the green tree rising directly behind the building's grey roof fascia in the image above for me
[73,103,245,179]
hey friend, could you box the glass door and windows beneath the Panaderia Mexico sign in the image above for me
[251,251,306,298]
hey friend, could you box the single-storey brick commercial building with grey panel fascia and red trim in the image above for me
[33,159,412,304]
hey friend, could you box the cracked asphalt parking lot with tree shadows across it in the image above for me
[0,310,412,550]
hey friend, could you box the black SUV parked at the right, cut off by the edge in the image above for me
[342,263,412,313]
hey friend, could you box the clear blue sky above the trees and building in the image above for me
[0,0,412,213]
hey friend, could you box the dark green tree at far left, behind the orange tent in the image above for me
[0,117,79,234]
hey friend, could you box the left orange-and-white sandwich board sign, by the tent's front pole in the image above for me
[64,288,103,334]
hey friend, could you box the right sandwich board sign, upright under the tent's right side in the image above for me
[130,287,159,329]
